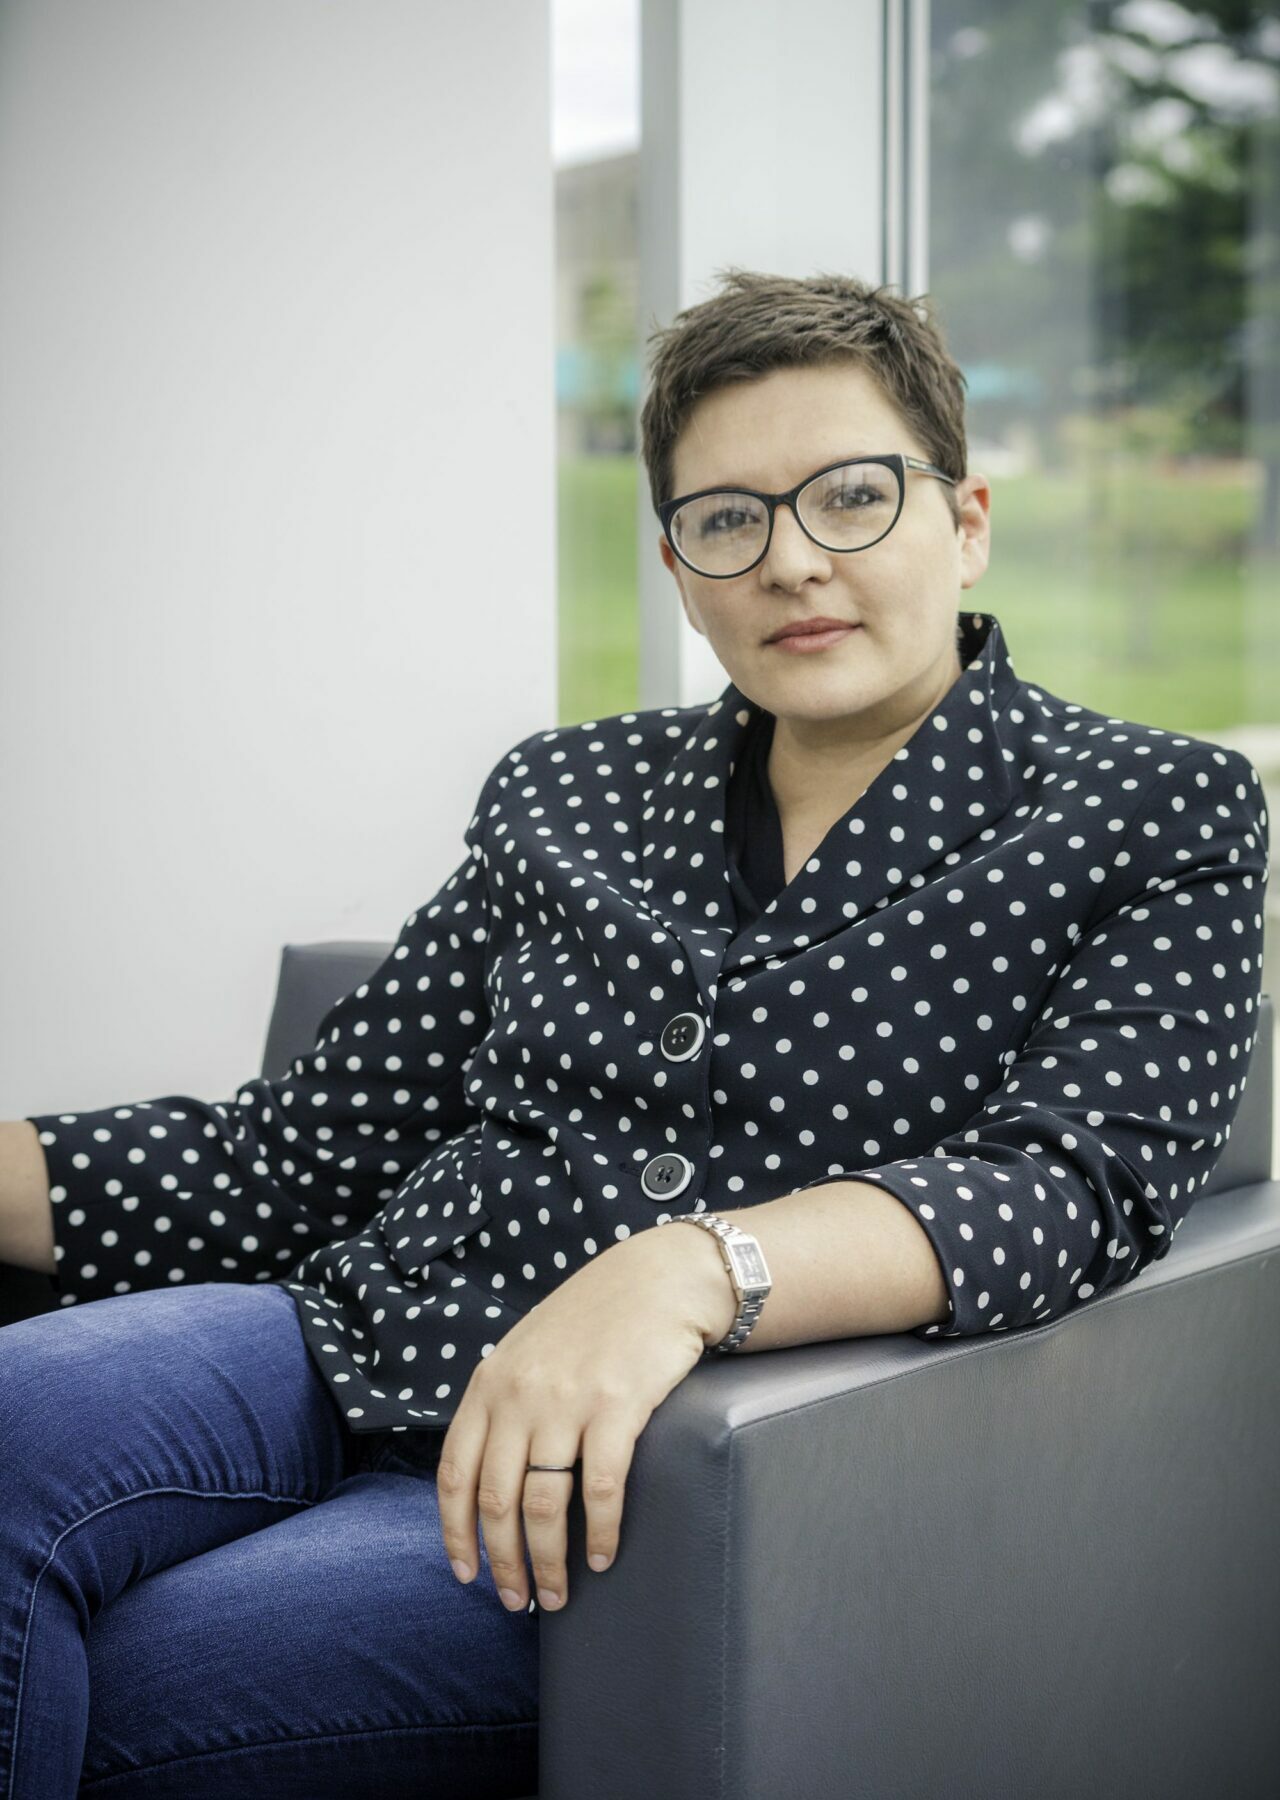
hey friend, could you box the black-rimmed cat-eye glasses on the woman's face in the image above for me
[657,450,956,581]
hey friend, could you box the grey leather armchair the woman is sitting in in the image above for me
[263,943,1280,1800]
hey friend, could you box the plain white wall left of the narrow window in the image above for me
[0,0,556,1118]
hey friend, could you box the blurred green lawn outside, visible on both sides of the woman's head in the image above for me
[558,455,1280,736]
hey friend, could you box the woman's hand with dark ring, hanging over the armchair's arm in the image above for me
[436,1228,736,1609]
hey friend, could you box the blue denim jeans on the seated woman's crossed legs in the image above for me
[0,1282,538,1800]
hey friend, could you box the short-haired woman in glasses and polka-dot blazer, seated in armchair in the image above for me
[0,272,1267,1796]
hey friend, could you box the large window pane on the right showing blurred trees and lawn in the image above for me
[929,0,1280,992]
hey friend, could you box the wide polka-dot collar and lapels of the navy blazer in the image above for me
[641,612,1021,1006]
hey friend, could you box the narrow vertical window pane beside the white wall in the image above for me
[551,0,640,725]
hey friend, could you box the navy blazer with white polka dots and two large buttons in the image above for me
[32,614,1269,1433]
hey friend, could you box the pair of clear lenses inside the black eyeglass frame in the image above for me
[672,463,898,576]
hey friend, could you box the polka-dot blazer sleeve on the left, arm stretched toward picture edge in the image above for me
[25,765,502,1305]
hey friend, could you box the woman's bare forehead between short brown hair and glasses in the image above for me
[672,362,924,493]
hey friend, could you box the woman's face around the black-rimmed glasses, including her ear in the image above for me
[659,362,990,733]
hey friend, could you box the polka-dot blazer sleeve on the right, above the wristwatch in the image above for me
[796,745,1269,1337]
